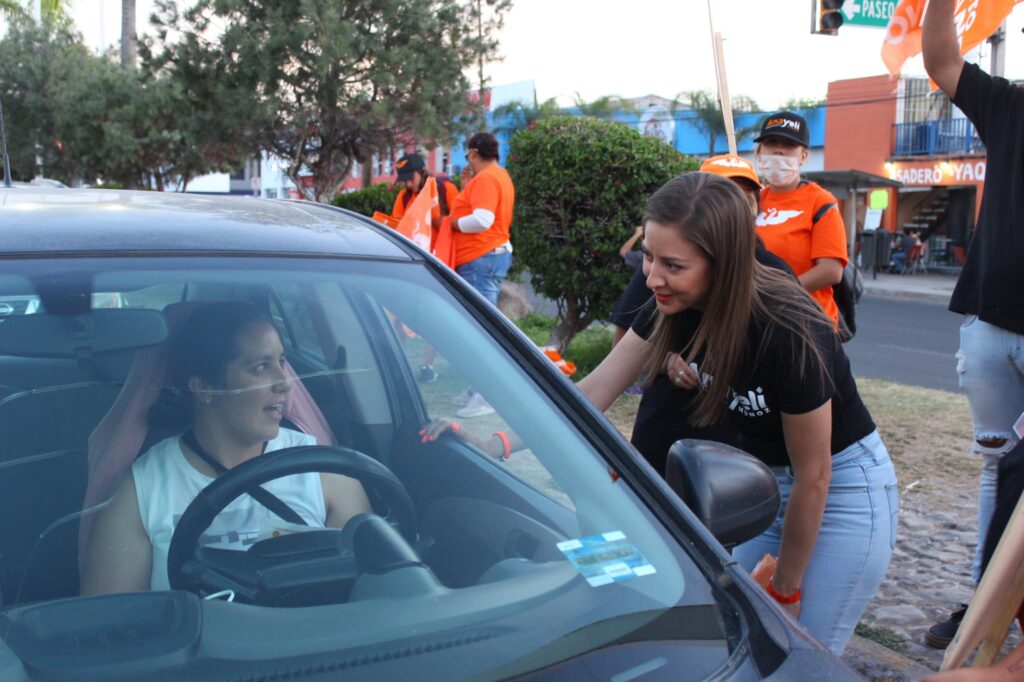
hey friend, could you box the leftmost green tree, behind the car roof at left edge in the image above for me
[0,16,248,189]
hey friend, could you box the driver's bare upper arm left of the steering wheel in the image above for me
[81,472,153,596]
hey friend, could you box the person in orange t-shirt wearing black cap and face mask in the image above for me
[754,112,848,325]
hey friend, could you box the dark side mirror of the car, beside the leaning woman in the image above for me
[665,439,781,548]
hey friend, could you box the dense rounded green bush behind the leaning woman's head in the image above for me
[508,116,696,351]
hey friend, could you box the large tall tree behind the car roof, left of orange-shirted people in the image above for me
[153,0,507,201]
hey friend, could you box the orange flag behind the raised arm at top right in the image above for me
[882,0,1022,78]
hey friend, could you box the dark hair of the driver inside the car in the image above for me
[148,301,270,428]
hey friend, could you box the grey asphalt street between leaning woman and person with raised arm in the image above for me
[846,296,961,391]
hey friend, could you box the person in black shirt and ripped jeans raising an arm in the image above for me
[922,0,1024,648]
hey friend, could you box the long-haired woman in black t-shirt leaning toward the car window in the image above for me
[579,173,898,654]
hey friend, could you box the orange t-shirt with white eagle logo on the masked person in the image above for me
[754,182,847,323]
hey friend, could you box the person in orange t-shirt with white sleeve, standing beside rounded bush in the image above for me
[452,133,515,305]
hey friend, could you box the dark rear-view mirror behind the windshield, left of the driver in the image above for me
[0,309,168,358]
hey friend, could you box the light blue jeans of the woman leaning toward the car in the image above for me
[733,431,899,655]
